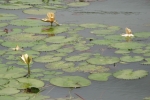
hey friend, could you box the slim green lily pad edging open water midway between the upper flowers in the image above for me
[80,23,107,28]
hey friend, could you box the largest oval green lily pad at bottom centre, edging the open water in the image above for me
[50,76,91,88]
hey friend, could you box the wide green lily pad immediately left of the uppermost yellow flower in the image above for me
[10,19,45,26]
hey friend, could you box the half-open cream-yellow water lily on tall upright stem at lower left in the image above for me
[21,54,32,76]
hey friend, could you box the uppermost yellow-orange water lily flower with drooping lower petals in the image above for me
[41,12,59,26]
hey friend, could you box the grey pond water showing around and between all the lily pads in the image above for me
[0,0,150,100]
